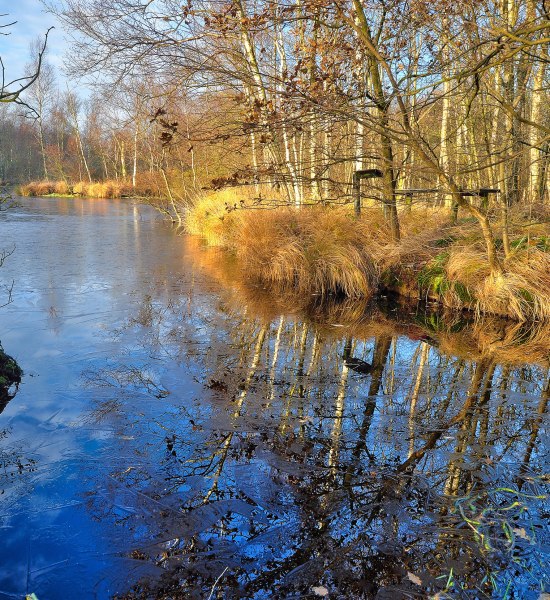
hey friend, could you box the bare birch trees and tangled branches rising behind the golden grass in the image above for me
[1,0,550,272]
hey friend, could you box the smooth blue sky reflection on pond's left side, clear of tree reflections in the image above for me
[0,200,203,598]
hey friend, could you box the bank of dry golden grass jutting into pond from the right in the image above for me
[186,192,550,321]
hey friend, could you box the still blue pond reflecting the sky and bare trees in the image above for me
[0,199,550,600]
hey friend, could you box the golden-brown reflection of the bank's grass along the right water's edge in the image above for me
[187,237,550,367]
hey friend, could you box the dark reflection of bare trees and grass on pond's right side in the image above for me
[87,241,550,599]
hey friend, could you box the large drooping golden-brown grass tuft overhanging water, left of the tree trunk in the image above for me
[234,207,378,298]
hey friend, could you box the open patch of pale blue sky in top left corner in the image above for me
[0,0,66,88]
